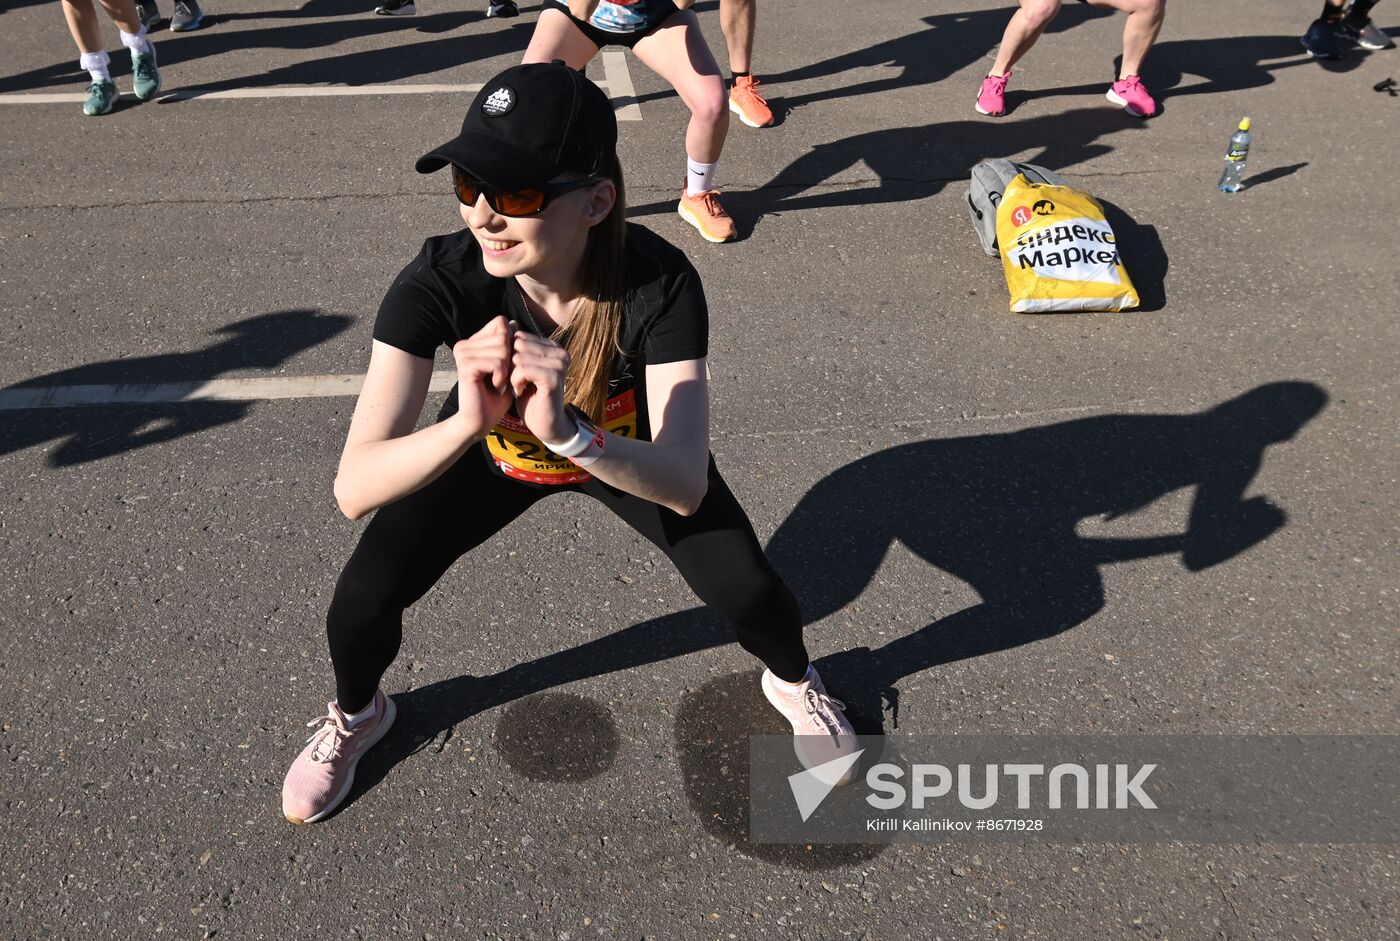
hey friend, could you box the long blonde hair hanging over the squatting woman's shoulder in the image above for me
[553,154,630,423]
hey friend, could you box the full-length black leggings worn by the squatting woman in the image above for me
[326,436,808,713]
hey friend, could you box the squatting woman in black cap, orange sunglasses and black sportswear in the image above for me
[283,63,854,823]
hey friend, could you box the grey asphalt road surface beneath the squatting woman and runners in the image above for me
[0,0,1400,941]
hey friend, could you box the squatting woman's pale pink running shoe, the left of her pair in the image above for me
[281,689,395,823]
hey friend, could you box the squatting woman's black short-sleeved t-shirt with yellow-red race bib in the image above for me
[374,223,710,486]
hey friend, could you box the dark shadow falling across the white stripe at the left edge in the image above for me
[0,309,354,468]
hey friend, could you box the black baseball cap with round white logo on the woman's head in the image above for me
[414,59,617,189]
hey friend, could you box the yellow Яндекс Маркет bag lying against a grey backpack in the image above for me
[997,174,1138,314]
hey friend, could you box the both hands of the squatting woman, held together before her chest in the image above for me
[452,316,577,444]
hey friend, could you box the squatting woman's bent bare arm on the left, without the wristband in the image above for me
[335,318,512,520]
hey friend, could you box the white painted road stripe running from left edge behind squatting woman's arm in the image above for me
[0,370,456,412]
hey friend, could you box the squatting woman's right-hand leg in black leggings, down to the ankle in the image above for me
[581,458,809,683]
